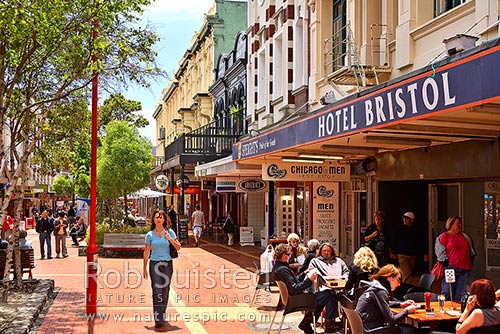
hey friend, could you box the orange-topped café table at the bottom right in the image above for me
[391,301,461,331]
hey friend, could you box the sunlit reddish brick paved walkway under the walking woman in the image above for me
[28,230,308,334]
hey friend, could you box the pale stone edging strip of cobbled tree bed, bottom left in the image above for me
[4,279,54,334]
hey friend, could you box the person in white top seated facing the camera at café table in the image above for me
[309,243,349,333]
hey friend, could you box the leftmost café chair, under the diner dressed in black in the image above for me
[267,281,316,334]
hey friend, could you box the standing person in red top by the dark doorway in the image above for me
[434,216,476,301]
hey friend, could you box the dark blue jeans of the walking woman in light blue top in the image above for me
[149,261,174,325]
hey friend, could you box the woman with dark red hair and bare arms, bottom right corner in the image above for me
[455,279,500,334]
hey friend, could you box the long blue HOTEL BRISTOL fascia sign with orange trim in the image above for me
[233,46,500,160]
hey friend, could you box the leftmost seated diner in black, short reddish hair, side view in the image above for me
[273,244,317,334]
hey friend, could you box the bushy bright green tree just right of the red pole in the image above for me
[97,121,154,229]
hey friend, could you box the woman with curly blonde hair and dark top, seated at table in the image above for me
[345,247,378,296]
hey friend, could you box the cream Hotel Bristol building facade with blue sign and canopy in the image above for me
[243,0,500,283]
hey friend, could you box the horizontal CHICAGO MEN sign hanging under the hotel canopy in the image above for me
[262,160,351,182]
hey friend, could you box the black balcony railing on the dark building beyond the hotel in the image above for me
[165,117,246,162]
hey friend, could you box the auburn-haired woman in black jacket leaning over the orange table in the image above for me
[356,264,420,333]
